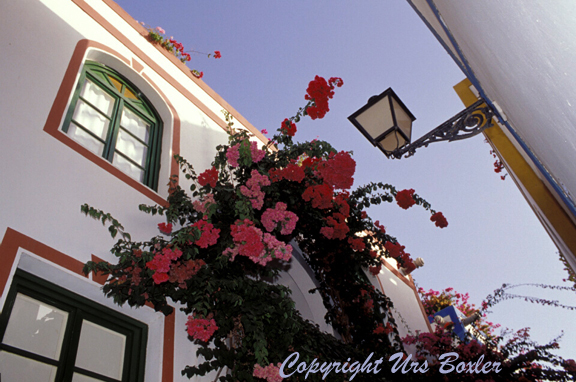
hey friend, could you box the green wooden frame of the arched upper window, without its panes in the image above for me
[61,60,163,191]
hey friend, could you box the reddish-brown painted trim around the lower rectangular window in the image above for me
[0,227,176,382]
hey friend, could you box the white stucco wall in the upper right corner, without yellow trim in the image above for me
[434,0,576,212]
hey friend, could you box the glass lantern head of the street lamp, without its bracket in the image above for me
[348,88,416,157]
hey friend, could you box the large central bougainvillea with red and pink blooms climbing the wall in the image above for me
[82,76,576,382]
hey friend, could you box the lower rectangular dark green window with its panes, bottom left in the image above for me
[0,271,148,382]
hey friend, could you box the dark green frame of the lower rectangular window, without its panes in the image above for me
[0,269,148,382]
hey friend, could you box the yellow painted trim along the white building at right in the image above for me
[454,79,576,268]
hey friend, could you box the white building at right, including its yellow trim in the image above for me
[408,0,576,271]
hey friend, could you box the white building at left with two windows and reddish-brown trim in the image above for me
[0,0,430,382]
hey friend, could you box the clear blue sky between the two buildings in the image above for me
[117,0,576,358]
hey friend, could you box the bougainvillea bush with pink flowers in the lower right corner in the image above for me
[403,284,576,381]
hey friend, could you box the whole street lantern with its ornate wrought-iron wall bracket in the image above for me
[348,88,495,159]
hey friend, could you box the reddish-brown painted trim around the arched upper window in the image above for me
[44,40,180,207]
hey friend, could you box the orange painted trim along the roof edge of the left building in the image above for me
[77,0,268,142]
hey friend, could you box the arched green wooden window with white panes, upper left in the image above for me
[62,61,162,190]
